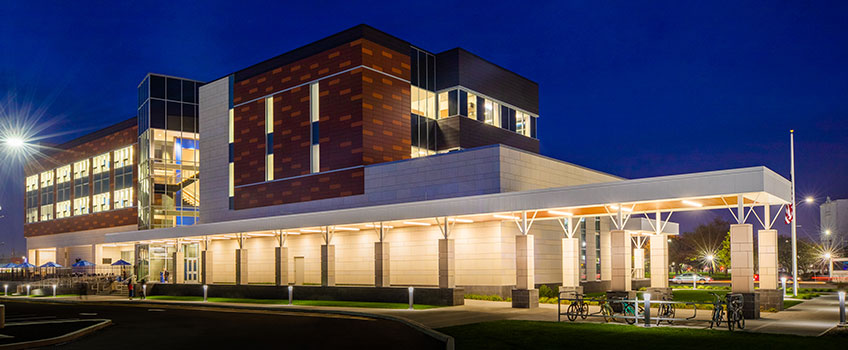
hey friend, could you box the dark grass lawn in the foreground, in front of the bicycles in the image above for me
[437,321,846,350]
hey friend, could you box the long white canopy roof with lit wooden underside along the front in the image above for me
[105,167,791,243]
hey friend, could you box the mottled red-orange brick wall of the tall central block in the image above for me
[233,39,411,209]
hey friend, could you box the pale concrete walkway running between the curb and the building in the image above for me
[4,293,839,336]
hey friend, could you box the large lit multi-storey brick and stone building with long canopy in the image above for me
[25,25,789,307]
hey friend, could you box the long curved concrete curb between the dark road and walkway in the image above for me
[0,297,454,350]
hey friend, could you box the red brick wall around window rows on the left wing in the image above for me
[24,126,138,237]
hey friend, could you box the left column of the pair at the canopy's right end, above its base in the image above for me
[730,224,754,293]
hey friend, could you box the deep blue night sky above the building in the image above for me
[0,0,848,253]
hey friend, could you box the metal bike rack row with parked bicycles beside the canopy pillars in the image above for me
[557,292,743,327]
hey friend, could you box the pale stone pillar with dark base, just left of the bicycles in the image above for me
[512,235,539,309]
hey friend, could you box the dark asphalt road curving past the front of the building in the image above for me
[4,301,444,349]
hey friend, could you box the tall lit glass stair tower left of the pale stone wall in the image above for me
[138,74,202,229]
